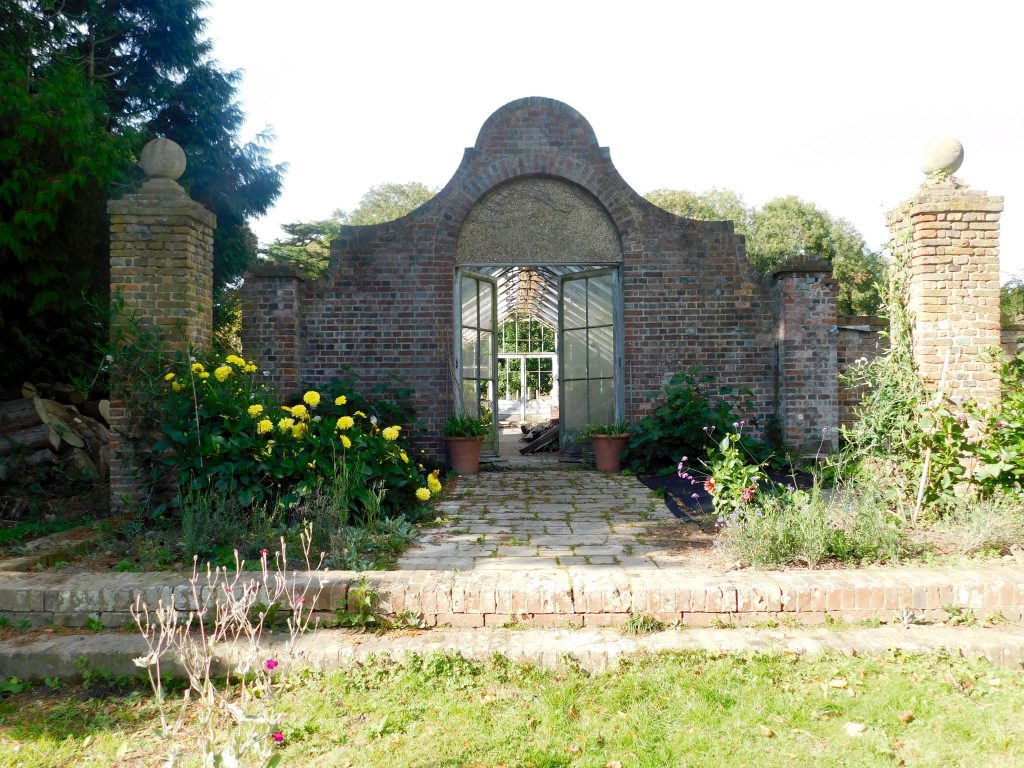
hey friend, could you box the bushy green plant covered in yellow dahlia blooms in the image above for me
[155,354,430,521]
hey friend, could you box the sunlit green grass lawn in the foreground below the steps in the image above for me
[0,653,1024,768]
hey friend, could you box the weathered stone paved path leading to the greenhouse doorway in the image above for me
[397,469,675,570]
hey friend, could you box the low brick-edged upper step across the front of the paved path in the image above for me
[0,563,1024,627]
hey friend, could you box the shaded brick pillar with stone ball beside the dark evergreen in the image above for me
[106,138,216,509]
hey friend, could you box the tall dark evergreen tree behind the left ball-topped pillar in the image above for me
[0,0,284,386]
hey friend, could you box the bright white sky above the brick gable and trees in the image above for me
[208,0,1024,279]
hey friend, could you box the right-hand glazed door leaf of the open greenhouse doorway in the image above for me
[558,269,622,445]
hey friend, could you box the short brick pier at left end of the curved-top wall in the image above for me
[241,263,303,394]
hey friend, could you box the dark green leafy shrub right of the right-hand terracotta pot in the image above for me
[626,368,770,474]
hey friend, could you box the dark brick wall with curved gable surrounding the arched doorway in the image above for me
[243,98,823,457]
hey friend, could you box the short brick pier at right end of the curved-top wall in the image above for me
[772,259,839,456]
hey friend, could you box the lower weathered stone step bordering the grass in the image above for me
[0,626,1024,679]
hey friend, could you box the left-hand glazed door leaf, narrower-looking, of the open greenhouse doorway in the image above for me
[455,270,498,454]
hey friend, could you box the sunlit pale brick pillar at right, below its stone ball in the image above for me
[887,176,1002,402]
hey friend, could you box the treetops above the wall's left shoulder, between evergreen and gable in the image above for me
[262,181,437,279]
